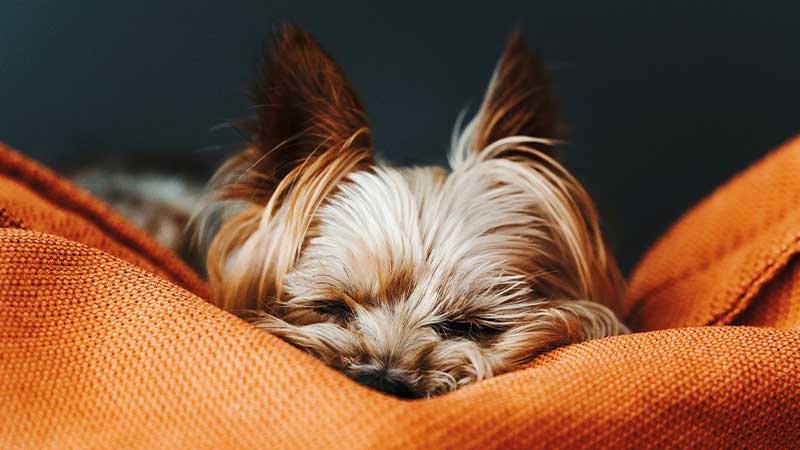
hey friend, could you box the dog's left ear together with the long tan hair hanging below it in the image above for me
[199,25,373,310]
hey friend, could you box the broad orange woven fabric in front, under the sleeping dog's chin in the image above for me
[0,142,800,449]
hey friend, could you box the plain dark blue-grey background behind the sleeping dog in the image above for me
[0,0,800,270]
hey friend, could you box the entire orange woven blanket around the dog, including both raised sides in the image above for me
[0,139,800,449]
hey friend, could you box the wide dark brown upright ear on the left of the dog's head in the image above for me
[226,25,372,199]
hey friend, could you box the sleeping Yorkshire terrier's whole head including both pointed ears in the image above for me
[197,27,625,397]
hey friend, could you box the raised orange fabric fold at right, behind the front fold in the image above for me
[626,138,800,330]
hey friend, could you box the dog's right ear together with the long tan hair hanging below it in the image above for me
[450,32,623,314]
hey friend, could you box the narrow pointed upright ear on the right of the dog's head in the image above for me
[454,31,561,163]
